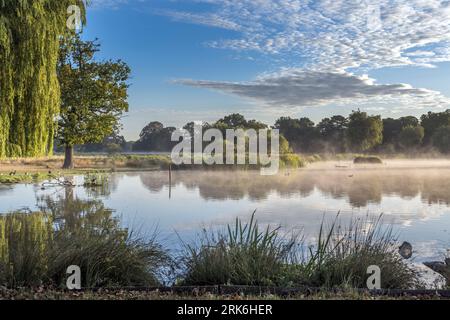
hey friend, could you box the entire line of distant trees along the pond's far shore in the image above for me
[70,110,450,153]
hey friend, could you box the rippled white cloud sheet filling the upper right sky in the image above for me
[167,0,450,69]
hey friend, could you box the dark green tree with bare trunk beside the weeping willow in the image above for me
[57,34,130,169]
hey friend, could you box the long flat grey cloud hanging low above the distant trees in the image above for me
[174,69,448,108]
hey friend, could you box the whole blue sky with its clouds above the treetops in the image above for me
[83,0,450,139]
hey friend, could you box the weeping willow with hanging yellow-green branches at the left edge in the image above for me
[0,0,86,158]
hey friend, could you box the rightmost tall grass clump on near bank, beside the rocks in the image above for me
[302,216,419,289]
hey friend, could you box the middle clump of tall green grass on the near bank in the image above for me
[182,214,297,286]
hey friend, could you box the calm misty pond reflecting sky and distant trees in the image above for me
[0,161,450,261]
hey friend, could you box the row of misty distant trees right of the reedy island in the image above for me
[275,110,450,153]
